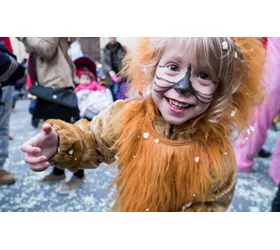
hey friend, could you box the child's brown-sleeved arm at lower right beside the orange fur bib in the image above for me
[184,166,236,212]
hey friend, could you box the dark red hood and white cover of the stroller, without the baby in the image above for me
[74,56,113,120]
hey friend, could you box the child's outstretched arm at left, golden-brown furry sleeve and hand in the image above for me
[22,101,129,172]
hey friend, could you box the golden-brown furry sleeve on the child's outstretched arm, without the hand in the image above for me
[45,101,132,172]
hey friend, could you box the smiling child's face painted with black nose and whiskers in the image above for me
[152,41,218,125]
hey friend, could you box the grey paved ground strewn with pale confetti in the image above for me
[0,100,279,212]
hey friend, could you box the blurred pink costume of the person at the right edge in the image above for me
[235,37,280,184]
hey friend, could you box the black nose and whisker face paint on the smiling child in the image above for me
[154,65,218,104]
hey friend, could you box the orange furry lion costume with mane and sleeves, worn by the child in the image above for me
[46,38,264,212]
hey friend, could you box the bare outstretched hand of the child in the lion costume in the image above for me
[20,123,58,171]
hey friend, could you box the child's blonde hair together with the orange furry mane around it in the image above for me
[122,37,265,131]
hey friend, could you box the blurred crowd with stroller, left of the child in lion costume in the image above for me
[0,37,128,194]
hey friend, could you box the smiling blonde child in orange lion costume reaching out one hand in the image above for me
[21,37,264,212]
